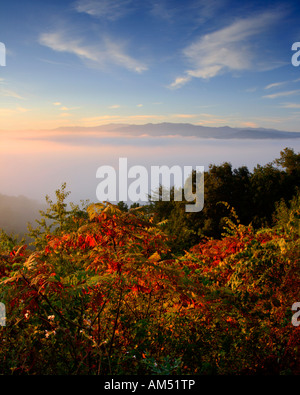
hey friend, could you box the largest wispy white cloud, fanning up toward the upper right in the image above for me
[169,12,280,88]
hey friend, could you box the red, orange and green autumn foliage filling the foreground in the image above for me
[0,151,300,374]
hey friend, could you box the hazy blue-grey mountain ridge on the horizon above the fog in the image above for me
[55,122,300,139]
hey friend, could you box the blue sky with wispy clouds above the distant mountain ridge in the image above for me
[0,0,300,131]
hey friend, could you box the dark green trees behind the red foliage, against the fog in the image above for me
[152,148,300,253]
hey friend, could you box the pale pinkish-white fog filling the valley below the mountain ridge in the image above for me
[0,128,300,240]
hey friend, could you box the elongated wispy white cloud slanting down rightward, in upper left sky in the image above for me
[39,31,147,73]
